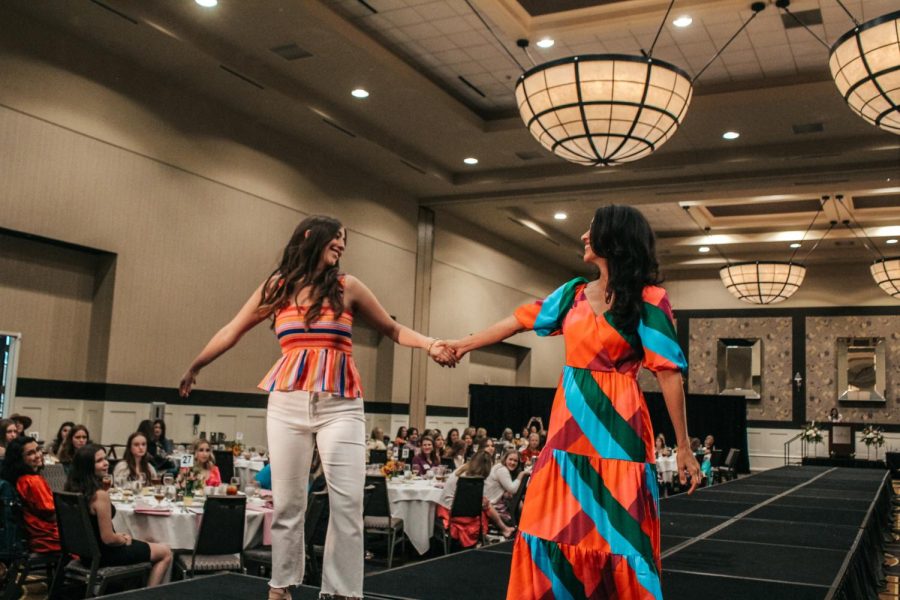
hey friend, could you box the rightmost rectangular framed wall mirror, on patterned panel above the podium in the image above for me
[837,337,887,402]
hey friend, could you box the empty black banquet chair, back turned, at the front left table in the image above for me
[174,496,247,578]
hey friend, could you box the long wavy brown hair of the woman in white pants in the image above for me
[259,215,346,328]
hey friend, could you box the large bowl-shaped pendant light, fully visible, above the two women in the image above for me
[516,0,766,166]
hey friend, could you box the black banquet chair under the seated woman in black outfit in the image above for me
[49,492,153,598]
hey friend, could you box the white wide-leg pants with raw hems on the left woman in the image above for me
[266,391,366,598]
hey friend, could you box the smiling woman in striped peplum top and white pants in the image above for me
[180,216,456,600]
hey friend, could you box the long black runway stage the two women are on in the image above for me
[102,466,891,600]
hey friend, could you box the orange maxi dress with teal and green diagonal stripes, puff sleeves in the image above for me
[507,277,687,600]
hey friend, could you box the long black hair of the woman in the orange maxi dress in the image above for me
[591,204,662,334]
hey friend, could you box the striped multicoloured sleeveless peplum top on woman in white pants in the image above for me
[259,305,362,398]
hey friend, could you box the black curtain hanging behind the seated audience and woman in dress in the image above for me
[469,385,750,473]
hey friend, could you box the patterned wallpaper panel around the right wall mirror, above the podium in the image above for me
[806,315,900,423]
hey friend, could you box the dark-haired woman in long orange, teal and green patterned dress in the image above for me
[452,206,700,600]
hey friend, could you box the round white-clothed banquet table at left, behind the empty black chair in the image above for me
[113,499,274,550]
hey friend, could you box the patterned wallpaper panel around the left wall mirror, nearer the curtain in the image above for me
[688,317,793,421]
